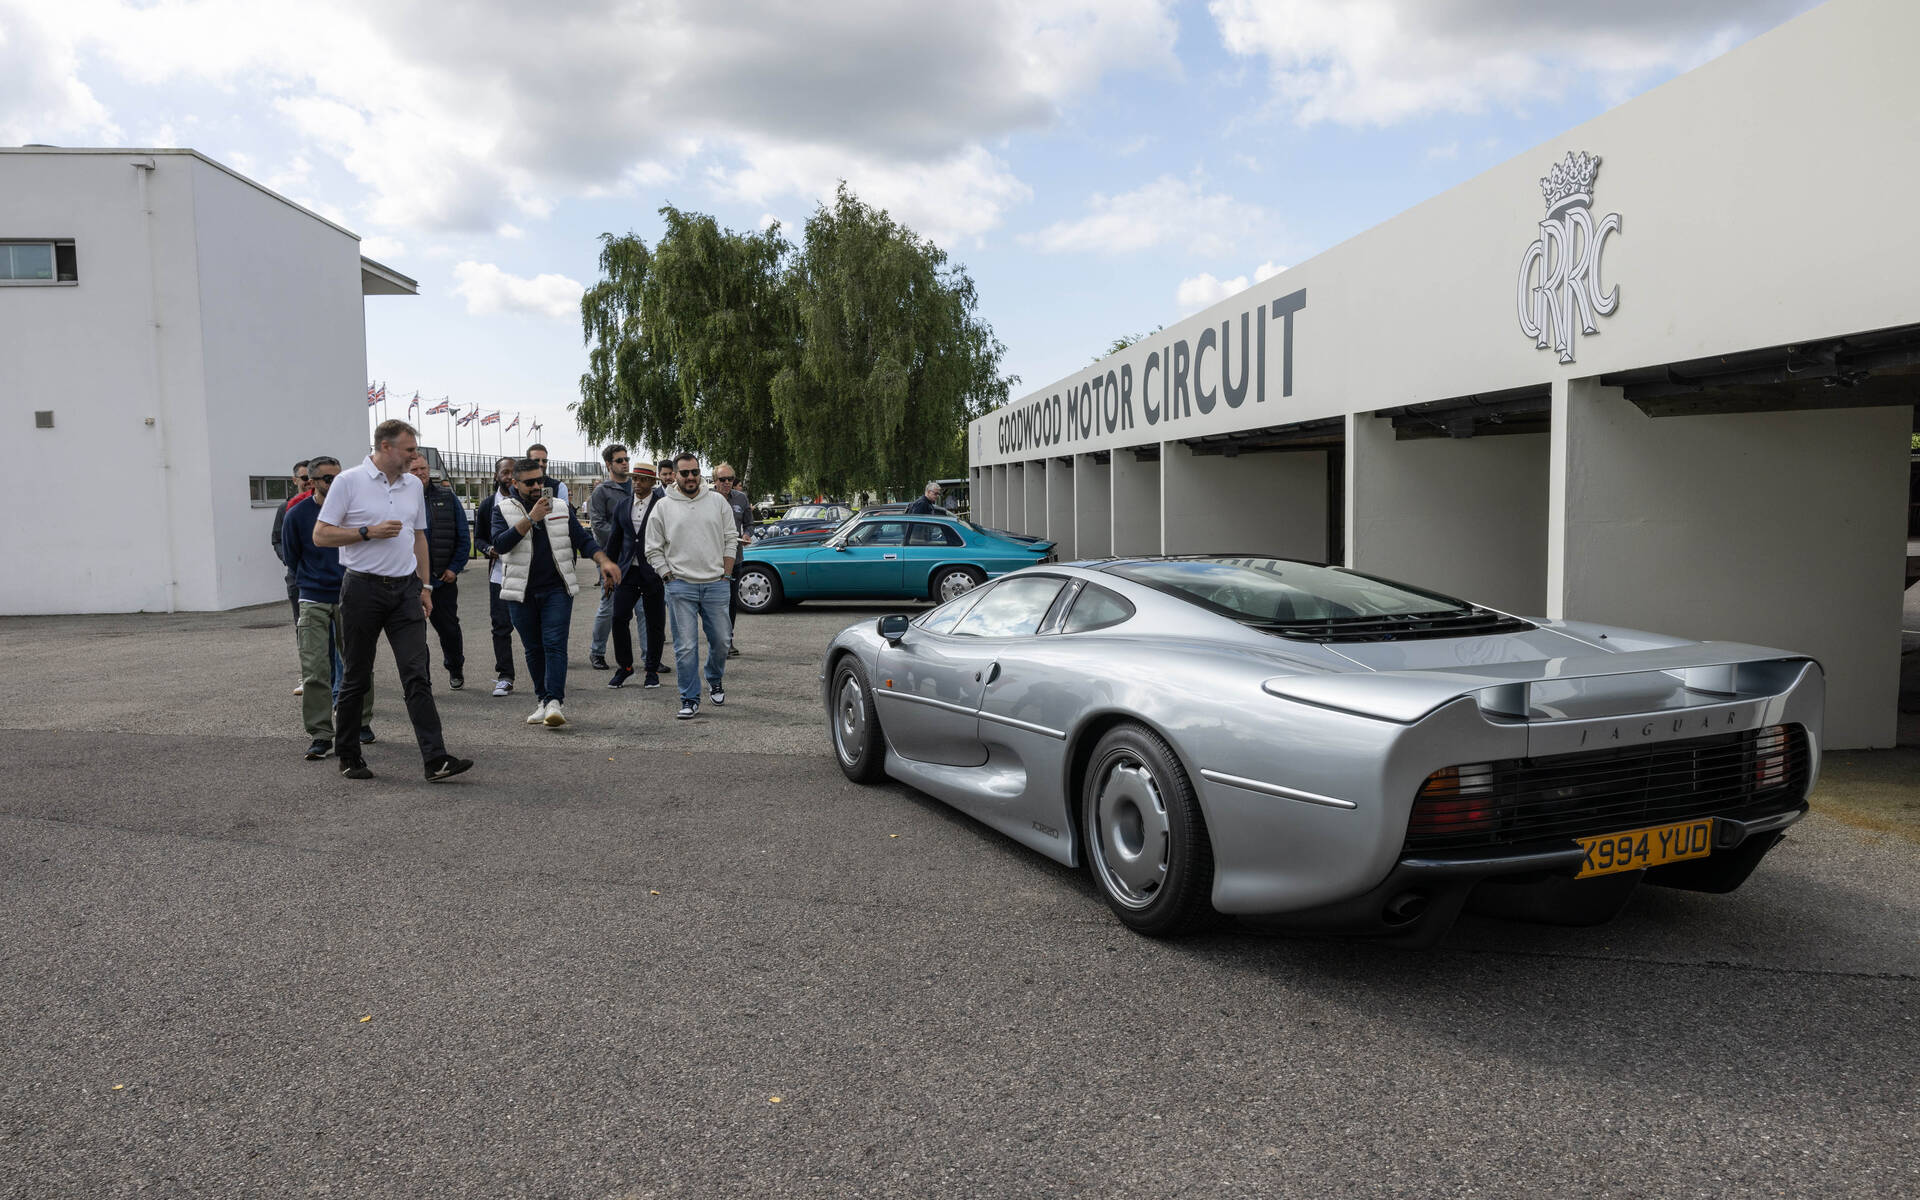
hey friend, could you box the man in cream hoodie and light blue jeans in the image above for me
[647,453,739,720]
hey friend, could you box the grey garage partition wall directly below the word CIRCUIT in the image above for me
[1160,442,1327,563]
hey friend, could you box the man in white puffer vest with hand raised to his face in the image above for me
[492,459,620,728]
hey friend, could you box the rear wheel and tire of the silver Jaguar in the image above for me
[1081,722,1215,937]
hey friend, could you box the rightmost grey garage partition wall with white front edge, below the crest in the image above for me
[1548,380,1912,749]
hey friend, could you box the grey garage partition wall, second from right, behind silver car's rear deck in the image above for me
[1346,413,1551,616]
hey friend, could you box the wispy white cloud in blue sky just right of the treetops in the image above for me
[1021,175,1273,257]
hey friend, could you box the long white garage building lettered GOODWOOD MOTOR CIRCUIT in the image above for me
[970,0,1920,747]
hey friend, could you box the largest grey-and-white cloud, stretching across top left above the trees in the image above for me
[15,0,1179,236]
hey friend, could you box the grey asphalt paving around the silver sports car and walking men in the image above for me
[0,588,1920,1200]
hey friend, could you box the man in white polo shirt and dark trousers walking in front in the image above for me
[313,420,472,781]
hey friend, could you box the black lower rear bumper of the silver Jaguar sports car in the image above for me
[1242,801,1807,947]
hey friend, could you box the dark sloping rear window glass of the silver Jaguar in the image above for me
[1108,559,1475,626]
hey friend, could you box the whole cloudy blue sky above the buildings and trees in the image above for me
[0,0,1812,457]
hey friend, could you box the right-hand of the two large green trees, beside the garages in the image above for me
[774,184,1012,493]
